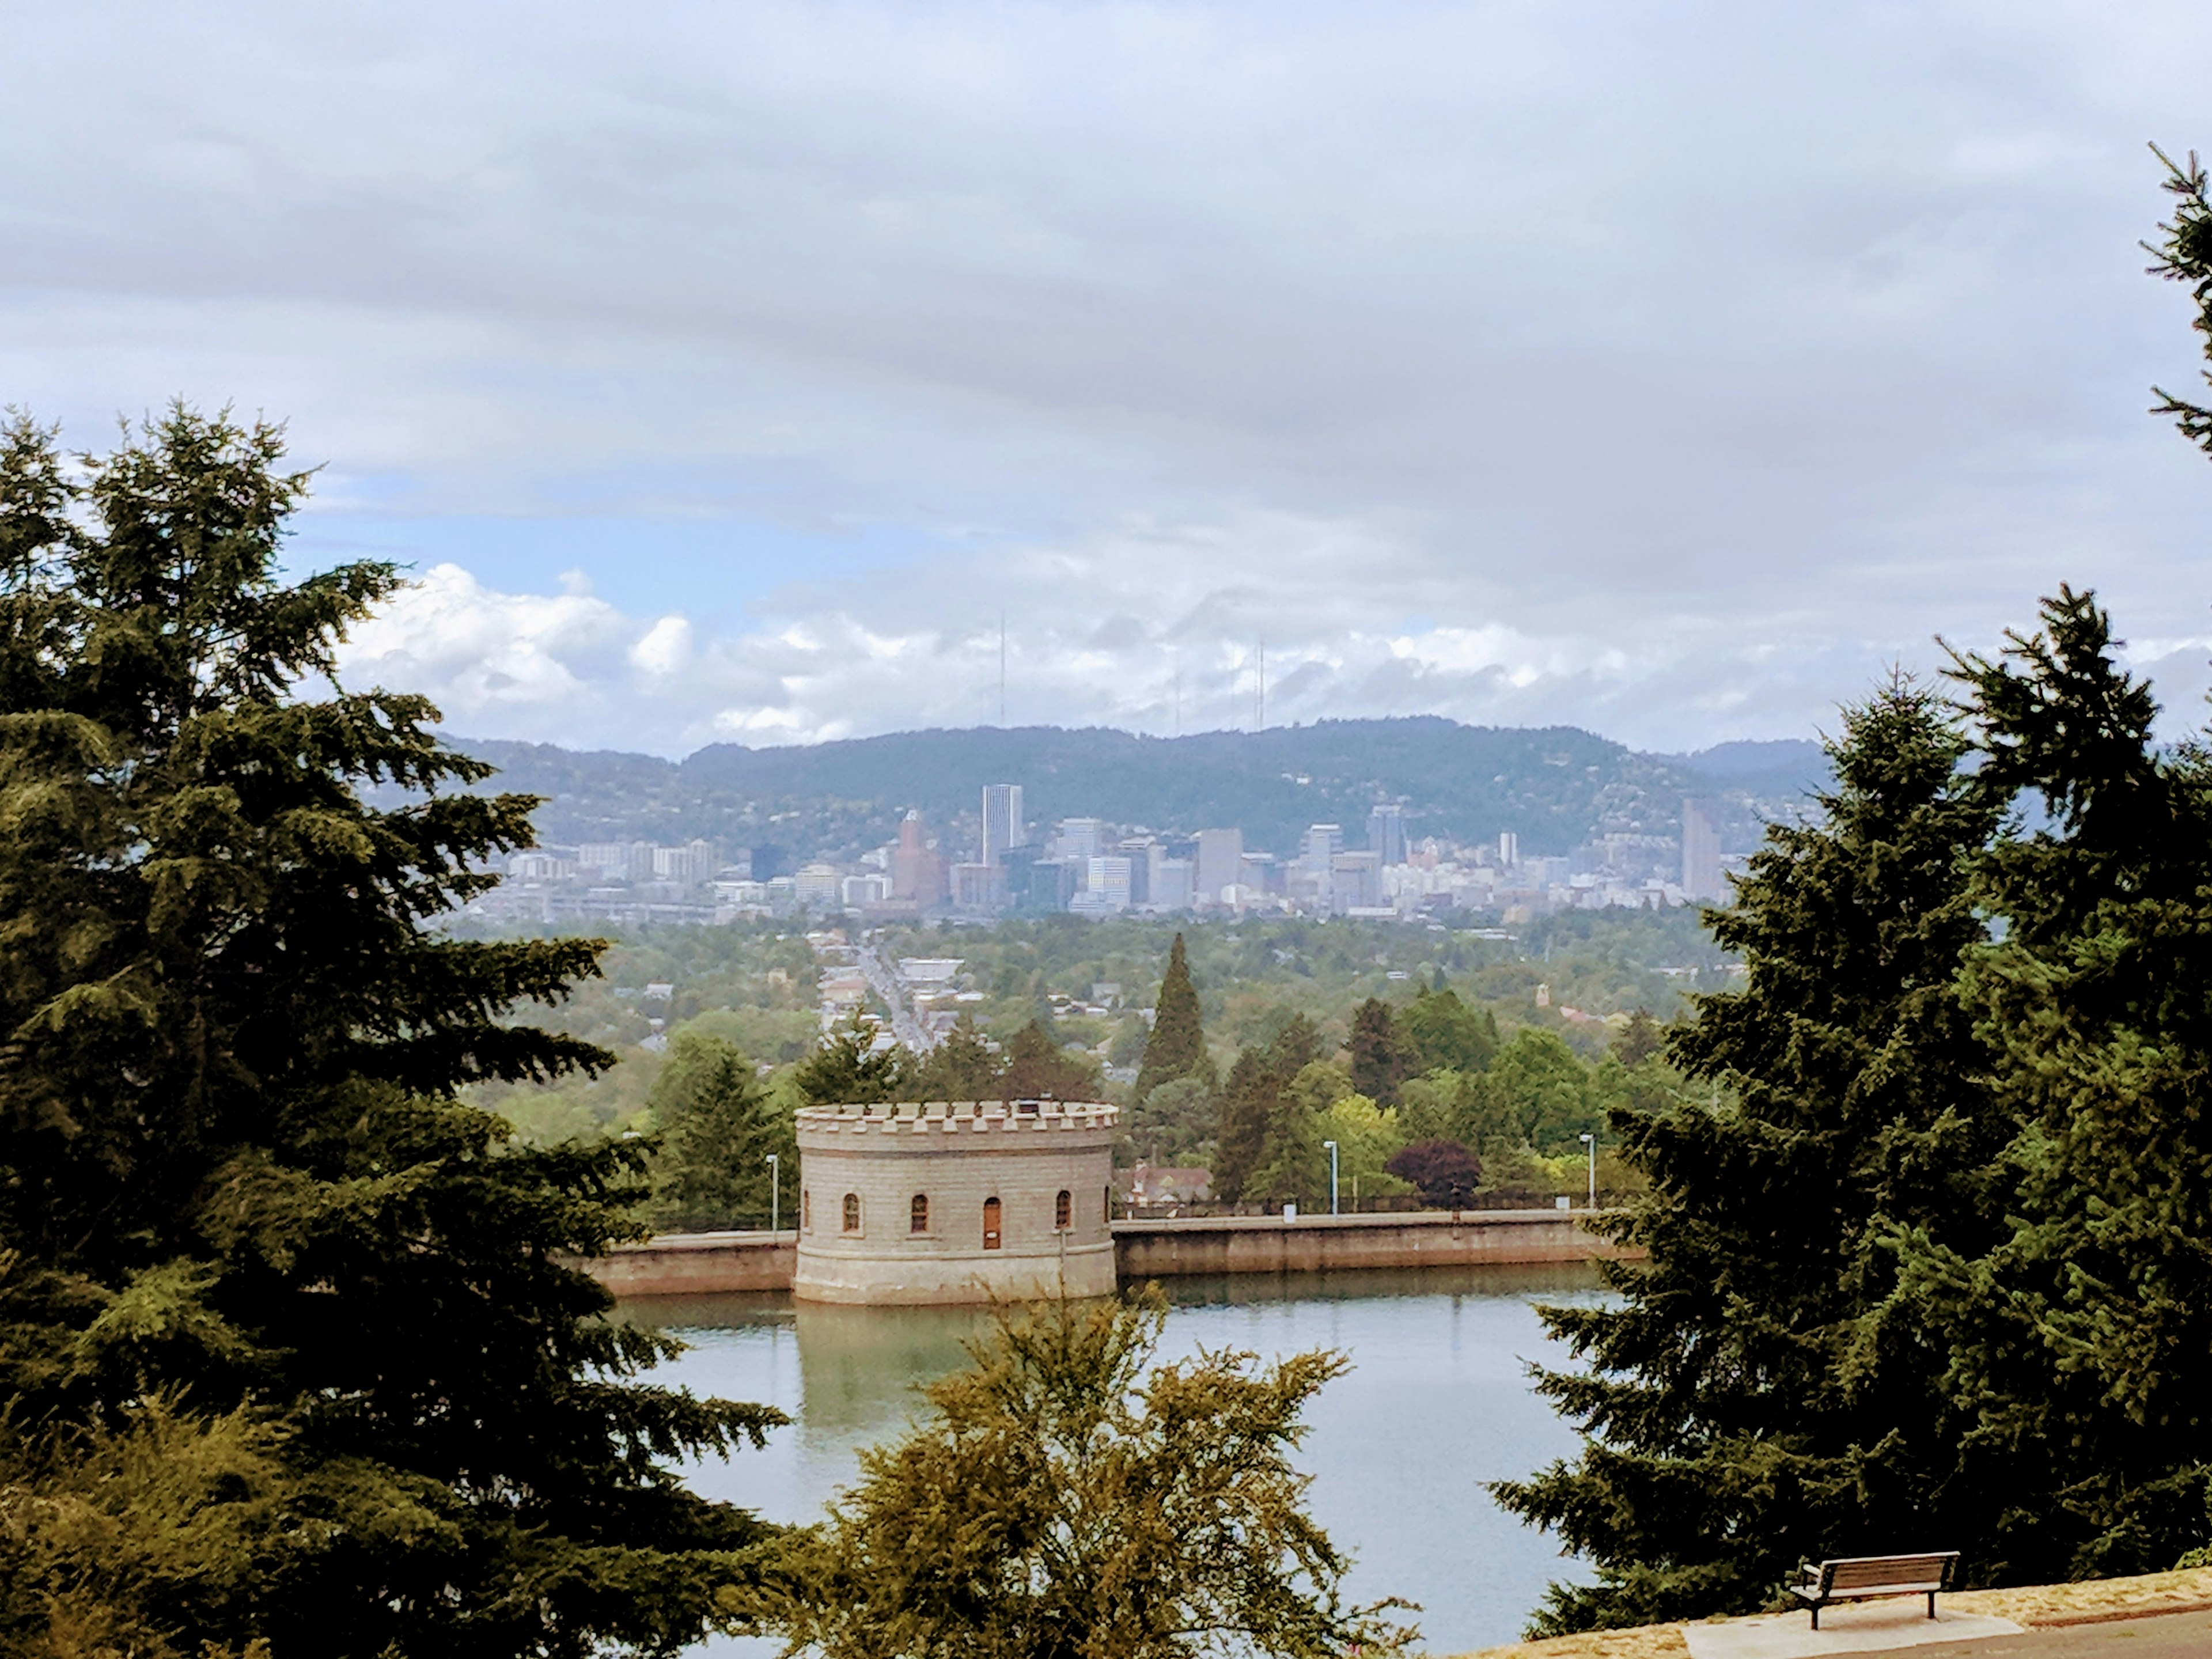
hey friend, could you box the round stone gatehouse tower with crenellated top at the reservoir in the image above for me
[792,1099,1119,1305]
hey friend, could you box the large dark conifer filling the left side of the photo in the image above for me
[0,407,781,1654]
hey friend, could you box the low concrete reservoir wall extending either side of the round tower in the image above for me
[579,1210,1626,1296]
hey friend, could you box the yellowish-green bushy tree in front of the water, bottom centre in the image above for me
[766,1296,1414,1659]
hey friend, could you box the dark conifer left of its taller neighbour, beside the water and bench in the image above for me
[1495,679,2006,1633]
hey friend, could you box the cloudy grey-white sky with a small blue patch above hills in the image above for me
[0,0,2212,754]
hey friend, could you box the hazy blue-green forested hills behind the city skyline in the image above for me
[435,717,1827,861]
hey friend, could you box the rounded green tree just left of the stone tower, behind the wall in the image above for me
[648,1029,798,1232]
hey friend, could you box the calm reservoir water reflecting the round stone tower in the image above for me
[624,1265,1601,1659]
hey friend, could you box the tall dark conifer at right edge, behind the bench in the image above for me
[1915,588,2212,1582]
